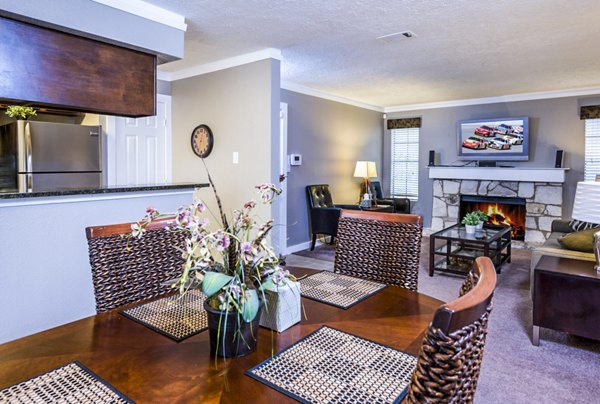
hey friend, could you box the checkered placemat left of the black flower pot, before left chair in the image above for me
[119,289,208,342]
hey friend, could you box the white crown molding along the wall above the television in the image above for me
[383,87,600,113]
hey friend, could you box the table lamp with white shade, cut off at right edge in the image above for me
[571,181,600,272]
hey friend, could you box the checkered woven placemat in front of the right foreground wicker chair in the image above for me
[246,326,417,403]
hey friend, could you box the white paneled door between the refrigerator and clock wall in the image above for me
[109,94,172,185]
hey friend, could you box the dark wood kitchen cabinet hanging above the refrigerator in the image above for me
[0,17,156,117]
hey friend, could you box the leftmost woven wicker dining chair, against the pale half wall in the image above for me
[85,219,185,313]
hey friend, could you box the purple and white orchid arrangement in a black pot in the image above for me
[131,175,295,357]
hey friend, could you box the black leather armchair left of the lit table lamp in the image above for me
[306,184,358,250]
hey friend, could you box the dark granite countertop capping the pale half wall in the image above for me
[0,183,209,199]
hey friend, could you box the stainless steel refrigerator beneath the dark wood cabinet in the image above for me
[0,121,103,192]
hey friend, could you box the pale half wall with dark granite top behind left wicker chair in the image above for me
[0,183,206,343]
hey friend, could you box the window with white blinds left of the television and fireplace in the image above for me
[390,128,419,200]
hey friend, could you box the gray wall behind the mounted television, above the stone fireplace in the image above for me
[383,97,596,227]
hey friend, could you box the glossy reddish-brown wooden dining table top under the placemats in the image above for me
[0,267,443,403]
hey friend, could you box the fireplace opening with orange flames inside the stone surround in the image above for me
[459,195,527,240]
